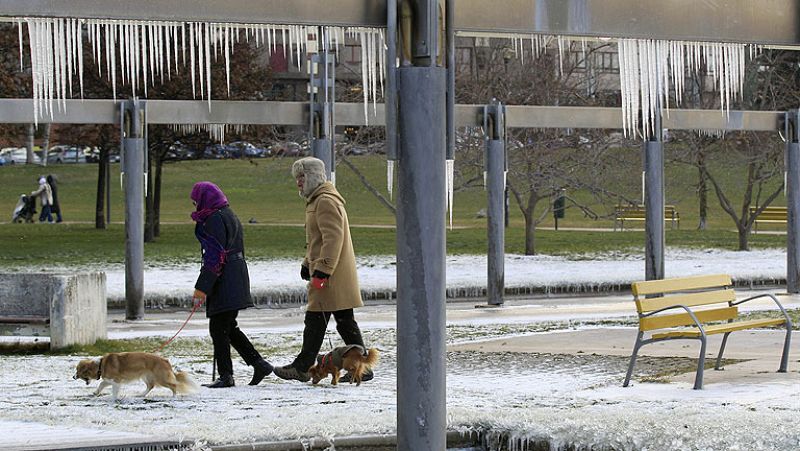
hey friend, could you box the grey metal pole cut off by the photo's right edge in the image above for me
[786,110,800,293]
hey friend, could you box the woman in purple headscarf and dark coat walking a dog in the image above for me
[191,182,272,388]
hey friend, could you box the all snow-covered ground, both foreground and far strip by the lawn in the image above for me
[0,250,800,451]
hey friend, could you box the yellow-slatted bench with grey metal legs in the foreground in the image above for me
[622,274,792,390]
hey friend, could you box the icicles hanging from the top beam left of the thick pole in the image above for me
[12,18,386,124]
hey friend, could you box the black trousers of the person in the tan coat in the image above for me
[292,309,364,371]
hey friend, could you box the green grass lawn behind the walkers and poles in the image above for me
[0,156,786,267]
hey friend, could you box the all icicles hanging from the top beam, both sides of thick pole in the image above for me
[16,18,760,139]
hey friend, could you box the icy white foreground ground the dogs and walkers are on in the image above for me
[0,308,800,451]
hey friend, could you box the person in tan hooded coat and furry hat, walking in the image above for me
[274,157,374,382]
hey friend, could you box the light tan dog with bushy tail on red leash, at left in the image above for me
[73,352,197,400]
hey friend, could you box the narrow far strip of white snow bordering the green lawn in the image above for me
[51,245,786,303]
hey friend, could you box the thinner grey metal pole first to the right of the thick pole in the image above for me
[484,101,506,306]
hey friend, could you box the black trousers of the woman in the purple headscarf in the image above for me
[208,310,261,377]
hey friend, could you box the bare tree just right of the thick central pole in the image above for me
[457,40,619,254]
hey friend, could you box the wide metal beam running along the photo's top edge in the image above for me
[0,0,800,46]
